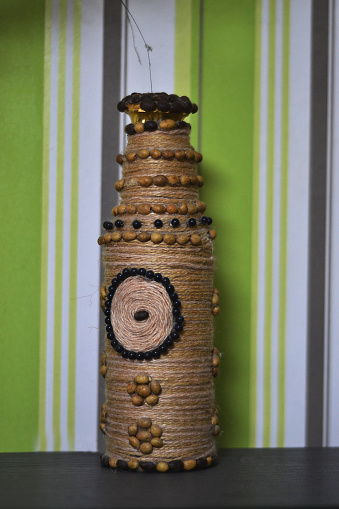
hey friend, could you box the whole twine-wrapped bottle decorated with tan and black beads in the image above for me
[98,93,220,472]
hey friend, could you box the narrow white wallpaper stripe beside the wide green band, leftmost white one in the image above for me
[45,0,59,451]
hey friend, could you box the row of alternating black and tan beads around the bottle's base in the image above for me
[100,454,217,473]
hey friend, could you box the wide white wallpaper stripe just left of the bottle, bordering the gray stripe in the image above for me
[75,0,103,451]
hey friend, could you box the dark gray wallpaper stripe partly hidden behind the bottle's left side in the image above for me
[98,0,121,452]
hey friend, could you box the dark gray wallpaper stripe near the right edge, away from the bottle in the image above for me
[306,0,329,447]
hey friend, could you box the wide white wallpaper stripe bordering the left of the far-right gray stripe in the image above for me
[284,0,312,447]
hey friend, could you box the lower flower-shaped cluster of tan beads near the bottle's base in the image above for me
[128,417,163,454]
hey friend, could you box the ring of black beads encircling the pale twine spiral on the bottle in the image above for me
[104,267,185,361]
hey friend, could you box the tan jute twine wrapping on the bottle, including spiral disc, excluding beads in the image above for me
[103,126,216,462]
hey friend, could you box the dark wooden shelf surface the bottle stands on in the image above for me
[0,448,339,509]
